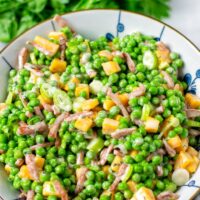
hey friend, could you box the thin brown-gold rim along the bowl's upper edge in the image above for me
[0,8,200,54]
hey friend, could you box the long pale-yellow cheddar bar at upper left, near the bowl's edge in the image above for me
[34,36,59,56]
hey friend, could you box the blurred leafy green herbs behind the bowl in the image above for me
[0,0,170,43]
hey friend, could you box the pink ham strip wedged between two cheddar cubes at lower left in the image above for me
[25,154,39,181]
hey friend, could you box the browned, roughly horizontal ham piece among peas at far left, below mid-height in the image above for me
[17,121,48,135]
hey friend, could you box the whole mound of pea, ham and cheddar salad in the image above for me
[0,16,200,200]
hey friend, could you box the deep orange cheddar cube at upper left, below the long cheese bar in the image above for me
[49,58,67,73]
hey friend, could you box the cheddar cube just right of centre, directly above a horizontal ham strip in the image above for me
[102,118,119,134]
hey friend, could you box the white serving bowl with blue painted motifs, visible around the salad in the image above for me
[0,9,200,200]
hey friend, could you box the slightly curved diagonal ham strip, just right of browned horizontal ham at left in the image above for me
[49,112,69,138]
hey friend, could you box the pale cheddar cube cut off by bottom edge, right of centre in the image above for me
[134,187,156,200]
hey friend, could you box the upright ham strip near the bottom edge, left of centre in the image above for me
[75,167,88,194]
